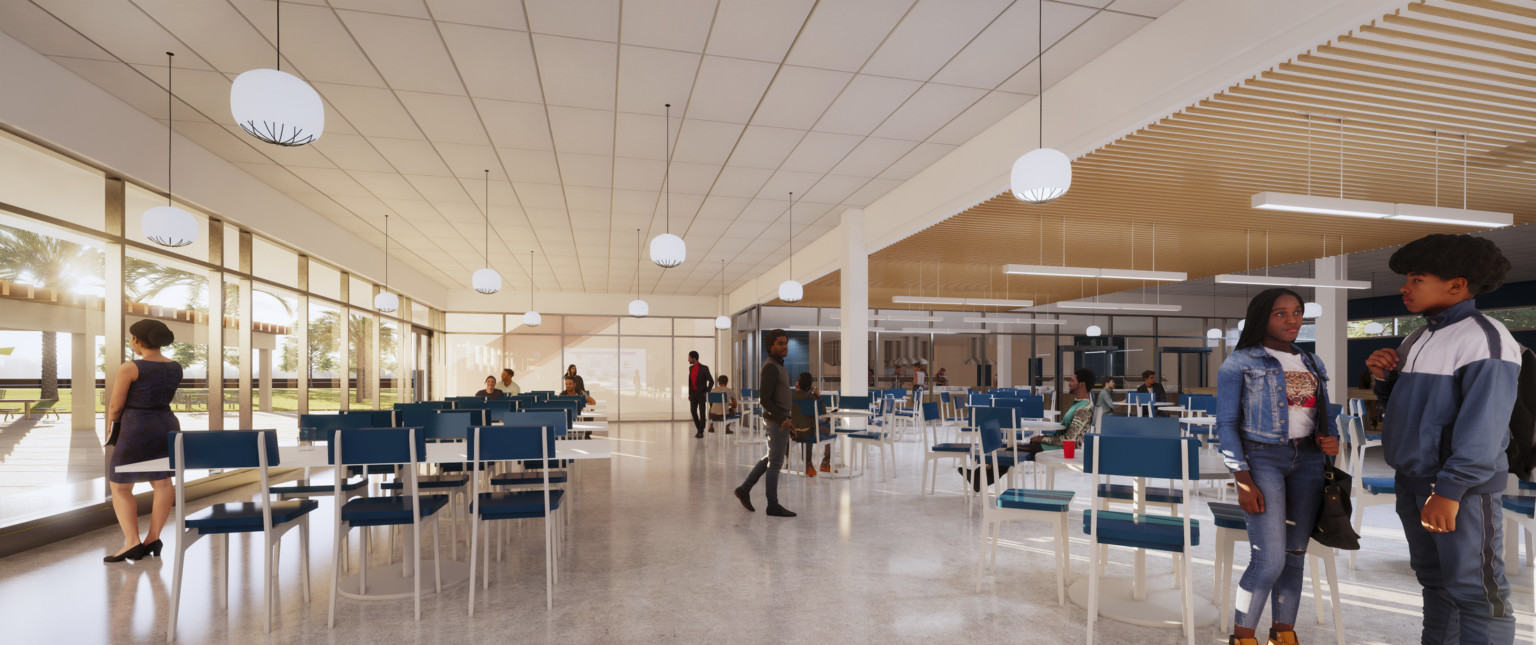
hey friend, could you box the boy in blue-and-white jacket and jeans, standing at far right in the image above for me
[1366,235,1521,643]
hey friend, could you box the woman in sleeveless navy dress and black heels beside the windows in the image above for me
[103,319,181,562]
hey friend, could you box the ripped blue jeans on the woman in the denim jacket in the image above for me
[1235,438,1322,630]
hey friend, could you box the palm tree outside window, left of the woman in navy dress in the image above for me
[0,226,103,401]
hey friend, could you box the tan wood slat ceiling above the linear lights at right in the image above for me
[774,0,1536,309]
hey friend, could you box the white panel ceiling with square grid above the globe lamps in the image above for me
[9,0,1178,295]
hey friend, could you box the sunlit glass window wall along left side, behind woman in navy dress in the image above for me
[0,132,442,527]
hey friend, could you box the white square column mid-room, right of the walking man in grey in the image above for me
[837,209,869,396]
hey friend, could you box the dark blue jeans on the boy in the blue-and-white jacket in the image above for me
[1398,485,1514,645]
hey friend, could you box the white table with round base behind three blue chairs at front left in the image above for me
[117,439,613,600]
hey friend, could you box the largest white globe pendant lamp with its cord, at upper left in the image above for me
[229,0,326,146]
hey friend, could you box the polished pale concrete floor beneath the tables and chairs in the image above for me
[0,424,1533,643]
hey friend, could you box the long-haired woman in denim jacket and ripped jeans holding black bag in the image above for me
[1217,289,1338,645]
